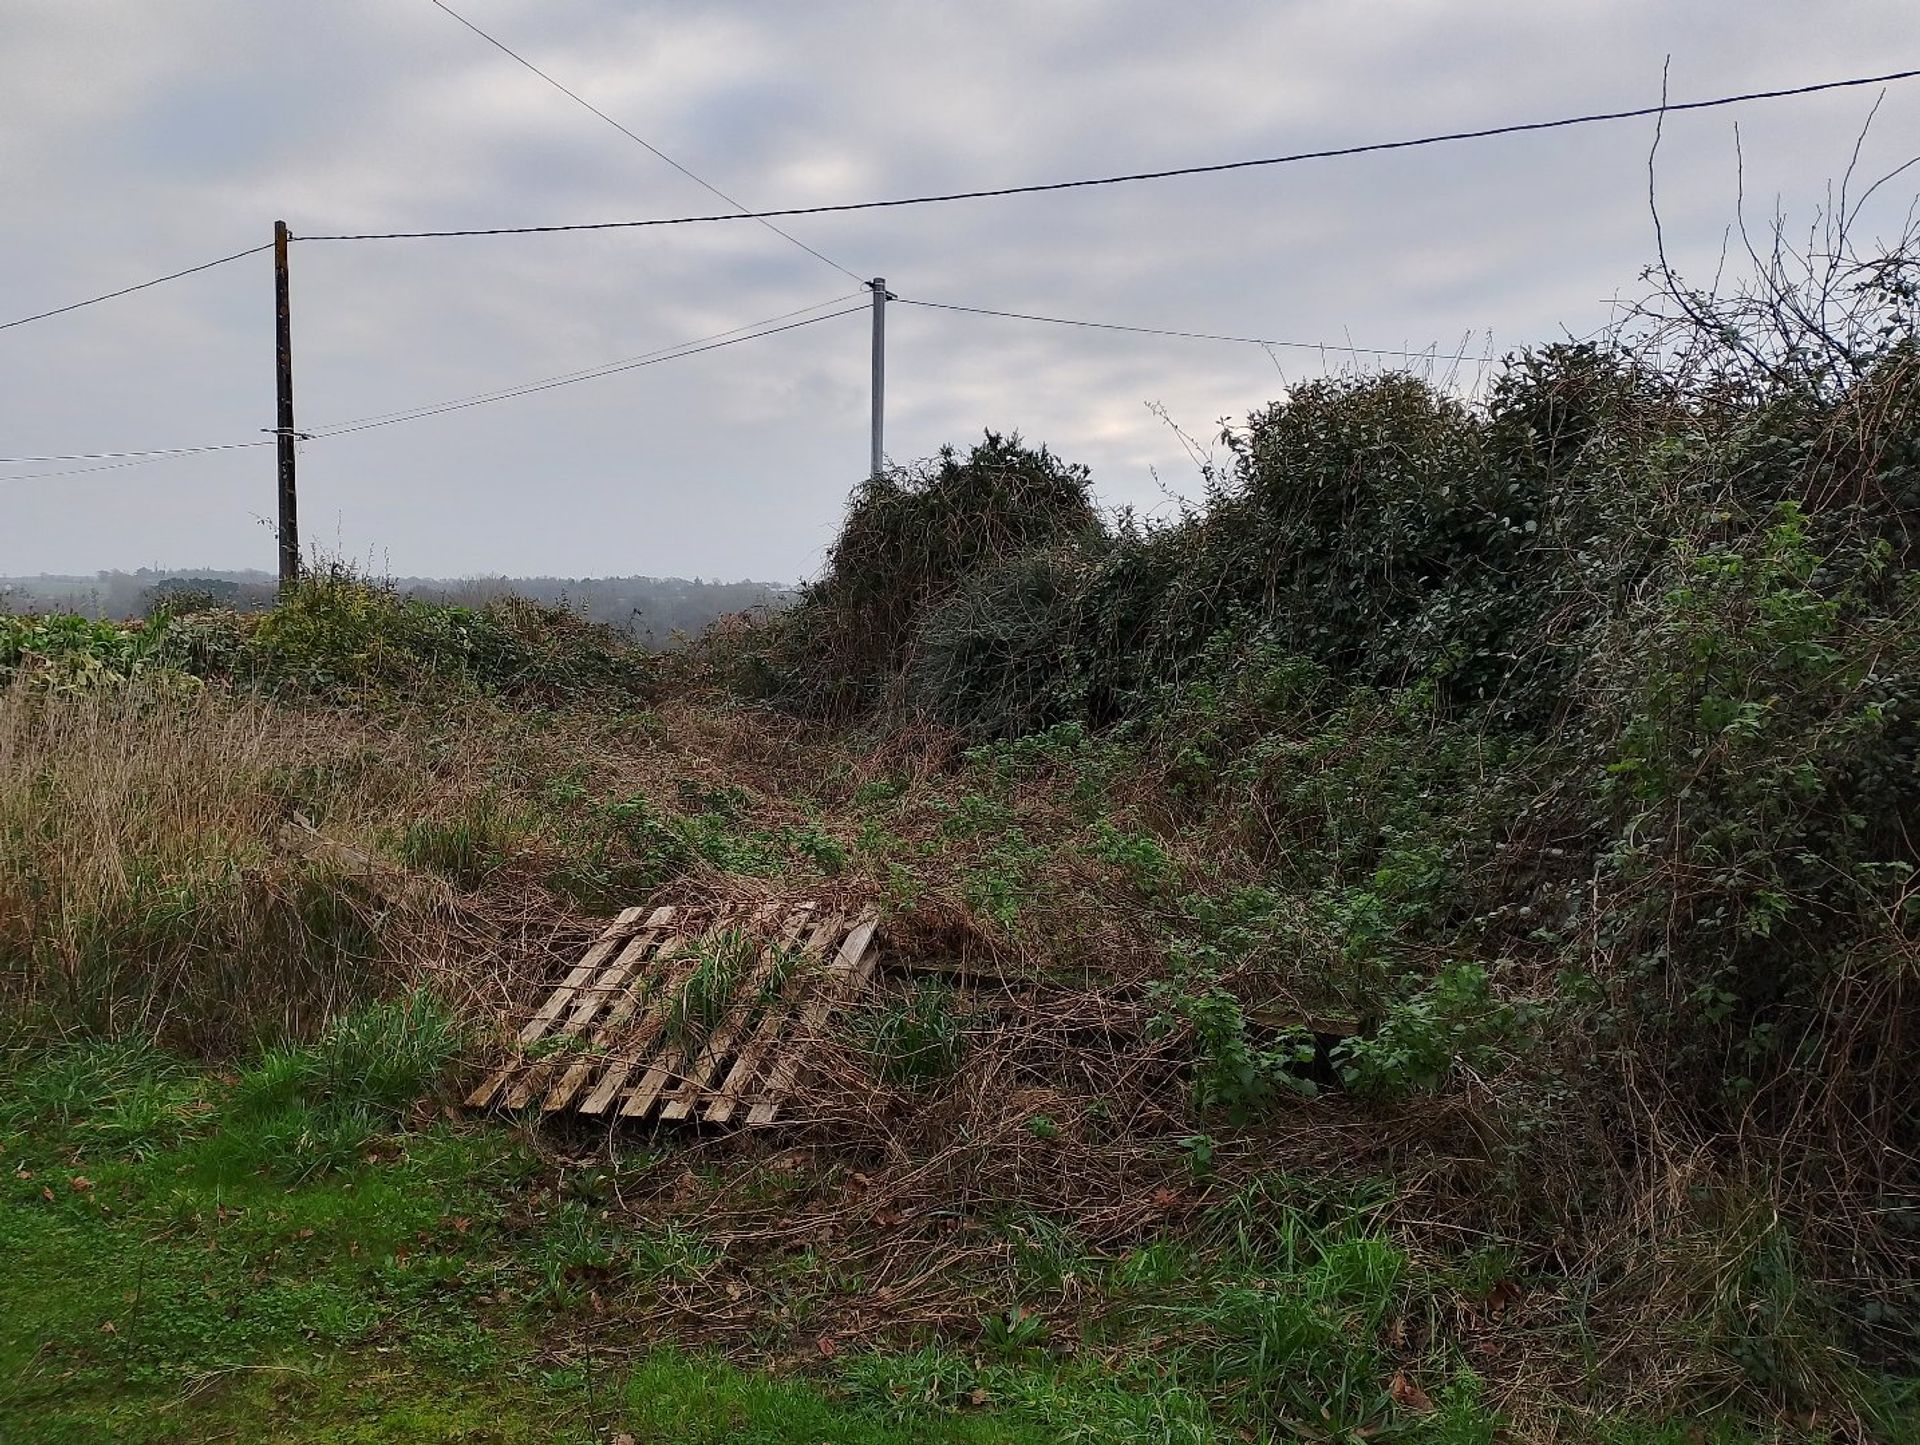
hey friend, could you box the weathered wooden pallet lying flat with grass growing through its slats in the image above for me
[467,904,877,1125]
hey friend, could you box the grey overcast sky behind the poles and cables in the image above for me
[0,0,1920,580]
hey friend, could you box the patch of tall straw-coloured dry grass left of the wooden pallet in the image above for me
[0,683,456,1052]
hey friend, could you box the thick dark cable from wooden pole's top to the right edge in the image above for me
[301,67,1920,242]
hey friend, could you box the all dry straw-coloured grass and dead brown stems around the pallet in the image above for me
[0,671,1904,1439]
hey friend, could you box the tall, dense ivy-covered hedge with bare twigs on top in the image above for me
[783,211,1920,1389]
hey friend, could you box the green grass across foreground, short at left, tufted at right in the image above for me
[0,1028,1827,1445]
